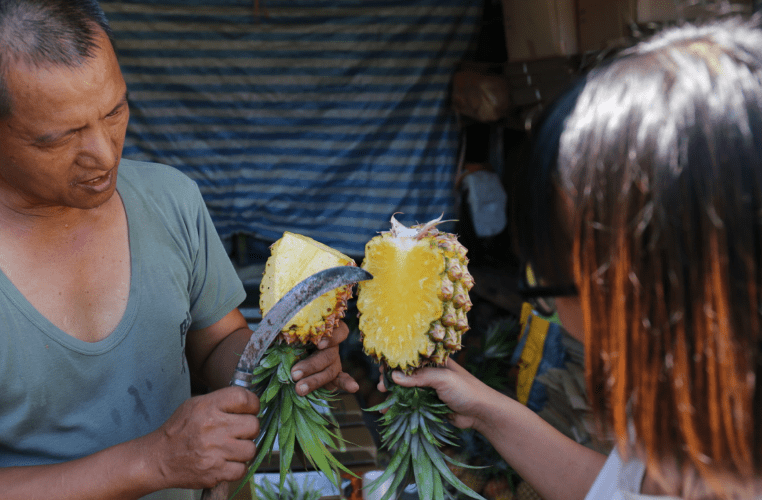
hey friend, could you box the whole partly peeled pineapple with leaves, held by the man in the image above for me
[236,232,355,493]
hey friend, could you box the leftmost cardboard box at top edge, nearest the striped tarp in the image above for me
[503,0,578,61]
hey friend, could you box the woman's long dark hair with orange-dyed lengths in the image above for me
[557,14,762,498]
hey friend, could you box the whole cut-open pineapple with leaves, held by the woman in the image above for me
[357,216,482,500]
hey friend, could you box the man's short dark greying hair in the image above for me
[0,0,113,119]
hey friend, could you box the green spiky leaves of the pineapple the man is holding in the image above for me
[233,342,351,496]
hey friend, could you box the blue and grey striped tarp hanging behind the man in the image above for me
[101,0,482,256]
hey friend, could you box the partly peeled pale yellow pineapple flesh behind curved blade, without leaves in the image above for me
[259,232,355,344]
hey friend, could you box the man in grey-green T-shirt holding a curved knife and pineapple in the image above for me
[0,0,358,499]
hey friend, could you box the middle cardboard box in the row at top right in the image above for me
[577,0,636,53]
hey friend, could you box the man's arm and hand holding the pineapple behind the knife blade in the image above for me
[186,309,359,395]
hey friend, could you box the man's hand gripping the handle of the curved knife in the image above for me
[146,387,259,489]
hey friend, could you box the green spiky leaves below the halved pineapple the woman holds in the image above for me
[364,377,484,500]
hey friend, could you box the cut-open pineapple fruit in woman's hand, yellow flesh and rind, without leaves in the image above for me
[357,216,474,373]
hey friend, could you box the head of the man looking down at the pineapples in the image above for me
[0,0,129,213]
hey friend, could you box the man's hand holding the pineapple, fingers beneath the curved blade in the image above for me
[291,321,360,396]
